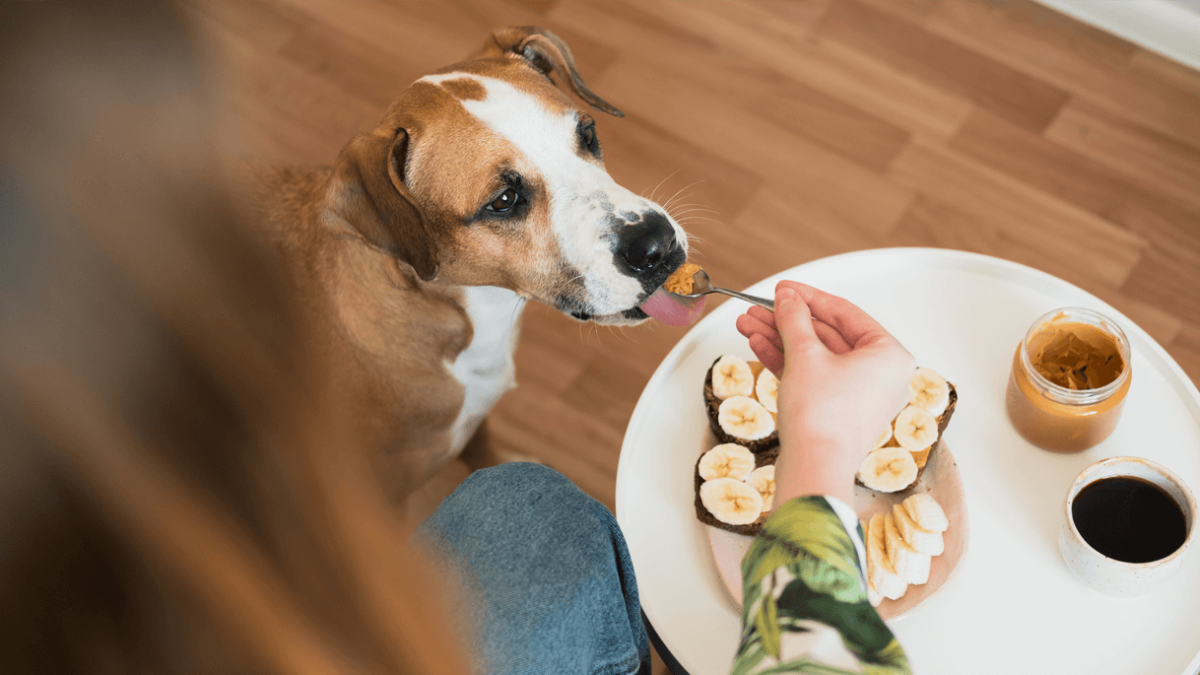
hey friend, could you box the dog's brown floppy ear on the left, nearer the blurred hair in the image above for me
[334,129,438,281]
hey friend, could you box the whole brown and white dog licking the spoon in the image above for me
[260,28,688,504]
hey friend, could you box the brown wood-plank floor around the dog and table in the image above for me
[190,0,1200,538]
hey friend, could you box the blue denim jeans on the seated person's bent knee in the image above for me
[414,464,650,675]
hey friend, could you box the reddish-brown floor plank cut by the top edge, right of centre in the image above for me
[815,0,1067,131]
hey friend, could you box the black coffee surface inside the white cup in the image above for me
[1070,476,1188,562]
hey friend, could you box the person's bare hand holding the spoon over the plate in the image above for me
[737,281,917,504]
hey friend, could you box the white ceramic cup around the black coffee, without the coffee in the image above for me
[1058,456,1196,597]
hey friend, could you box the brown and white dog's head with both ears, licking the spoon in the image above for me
[331,28,688,324]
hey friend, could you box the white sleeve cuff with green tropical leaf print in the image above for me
[733,496,911,675]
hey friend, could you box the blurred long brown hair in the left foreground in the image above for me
[0,1,464,675]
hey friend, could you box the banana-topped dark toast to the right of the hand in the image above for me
[854,368,959,492]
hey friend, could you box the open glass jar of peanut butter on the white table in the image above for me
[1006,307,1130,453]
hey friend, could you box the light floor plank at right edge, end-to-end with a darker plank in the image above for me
[1044,100,1200,208]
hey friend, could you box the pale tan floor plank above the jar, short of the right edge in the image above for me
[889,143,1147,288]
